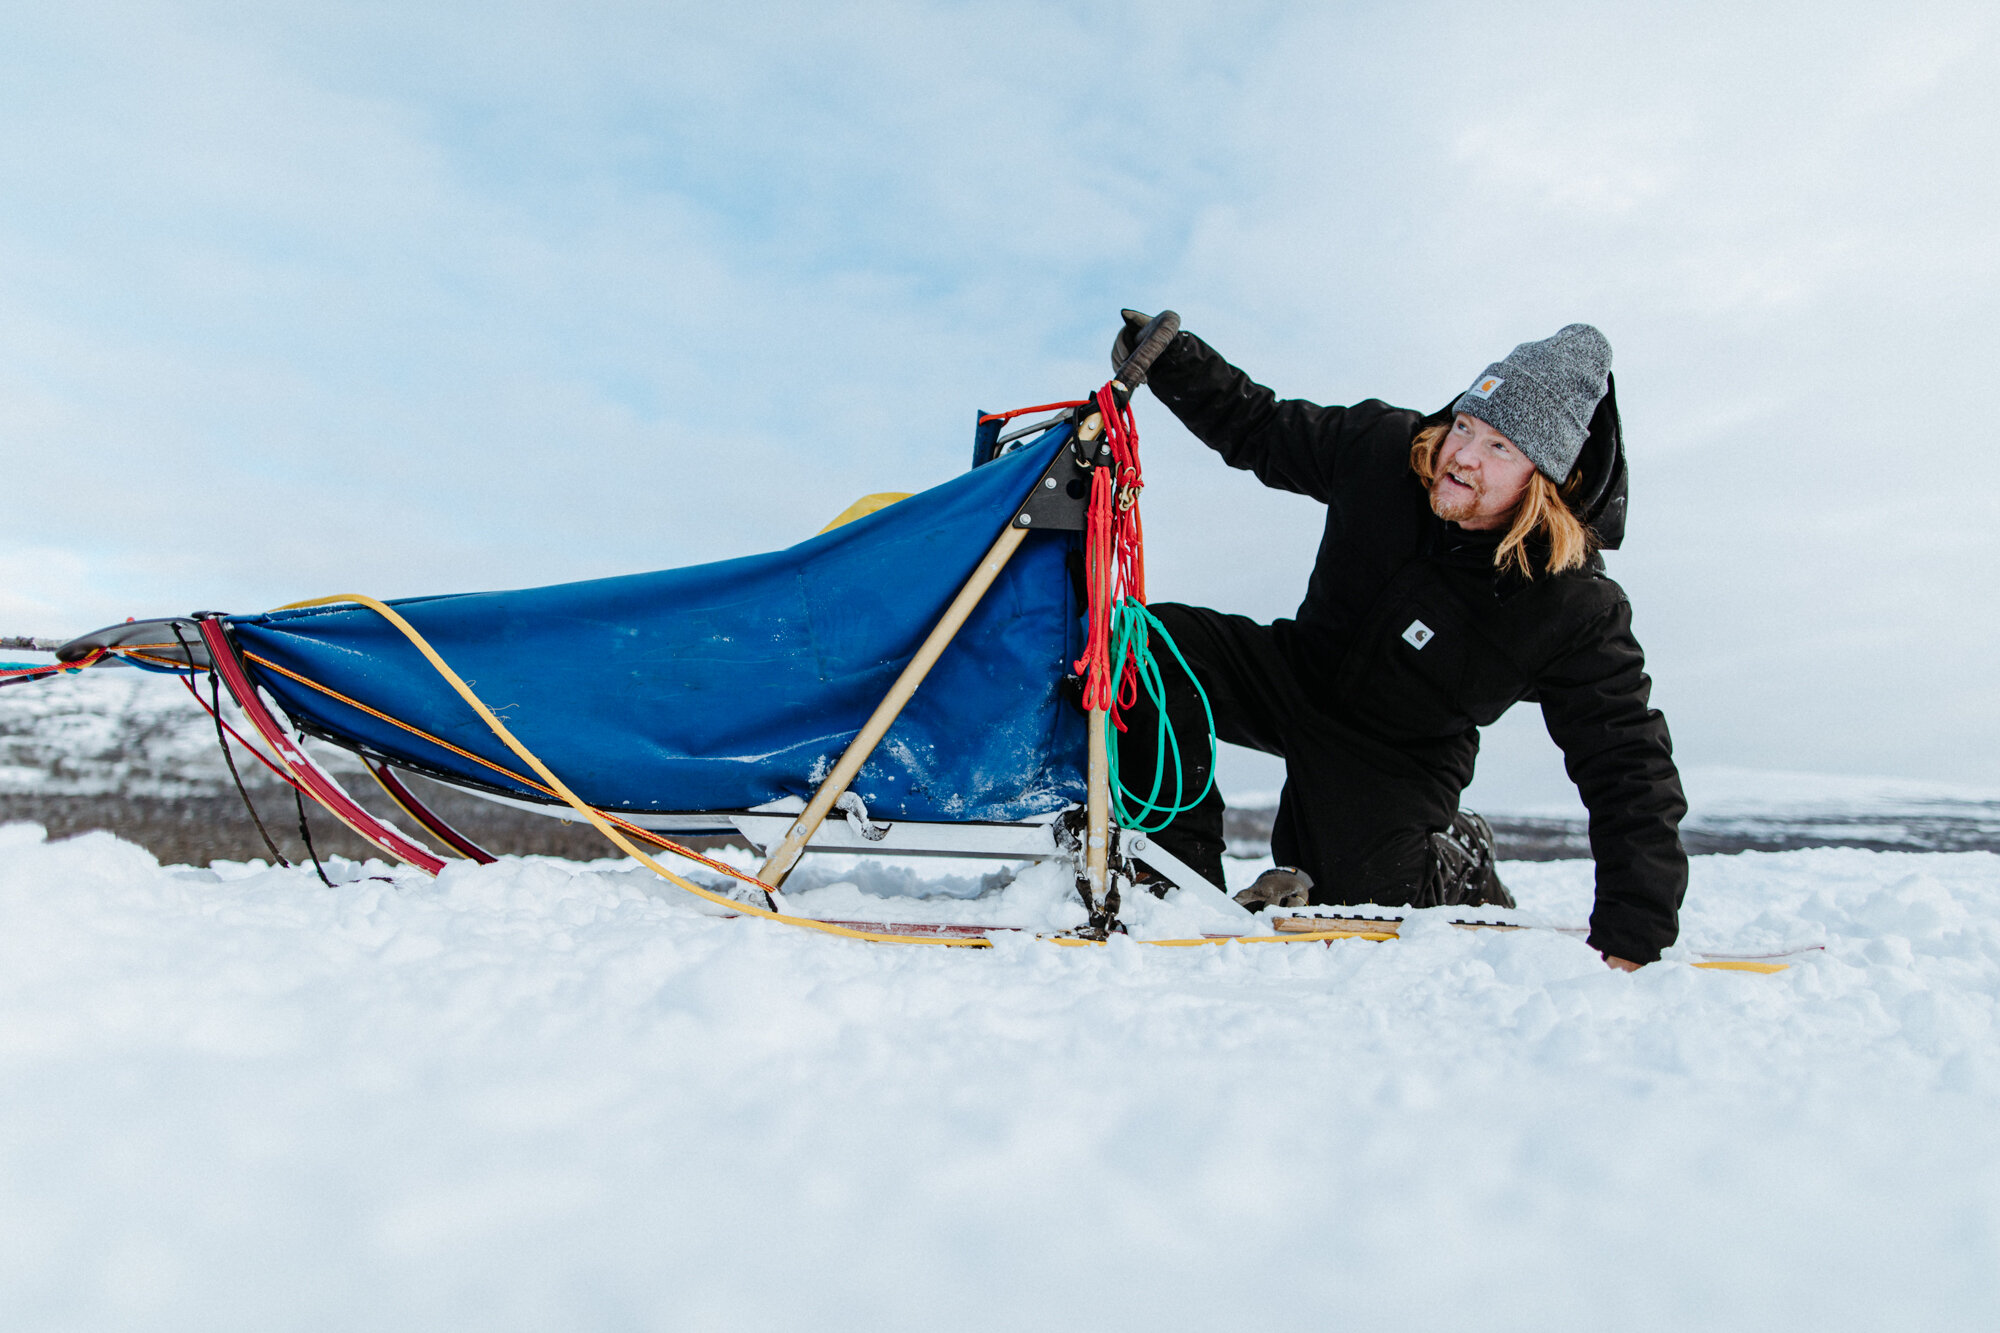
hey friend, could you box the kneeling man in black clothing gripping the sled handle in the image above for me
[1112,310,1688,969]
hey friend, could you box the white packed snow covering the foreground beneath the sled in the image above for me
[0,825,2000,1331]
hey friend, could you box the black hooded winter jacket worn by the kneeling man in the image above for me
[1148,332,1688,963]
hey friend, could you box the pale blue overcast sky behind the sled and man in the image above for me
[0,2,2000,795]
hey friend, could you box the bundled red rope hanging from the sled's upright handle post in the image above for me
[1076,384,1146,731]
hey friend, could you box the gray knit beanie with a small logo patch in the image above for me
[1452,324,1612,484]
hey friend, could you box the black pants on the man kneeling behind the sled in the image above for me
[1118,602,1498,907]
